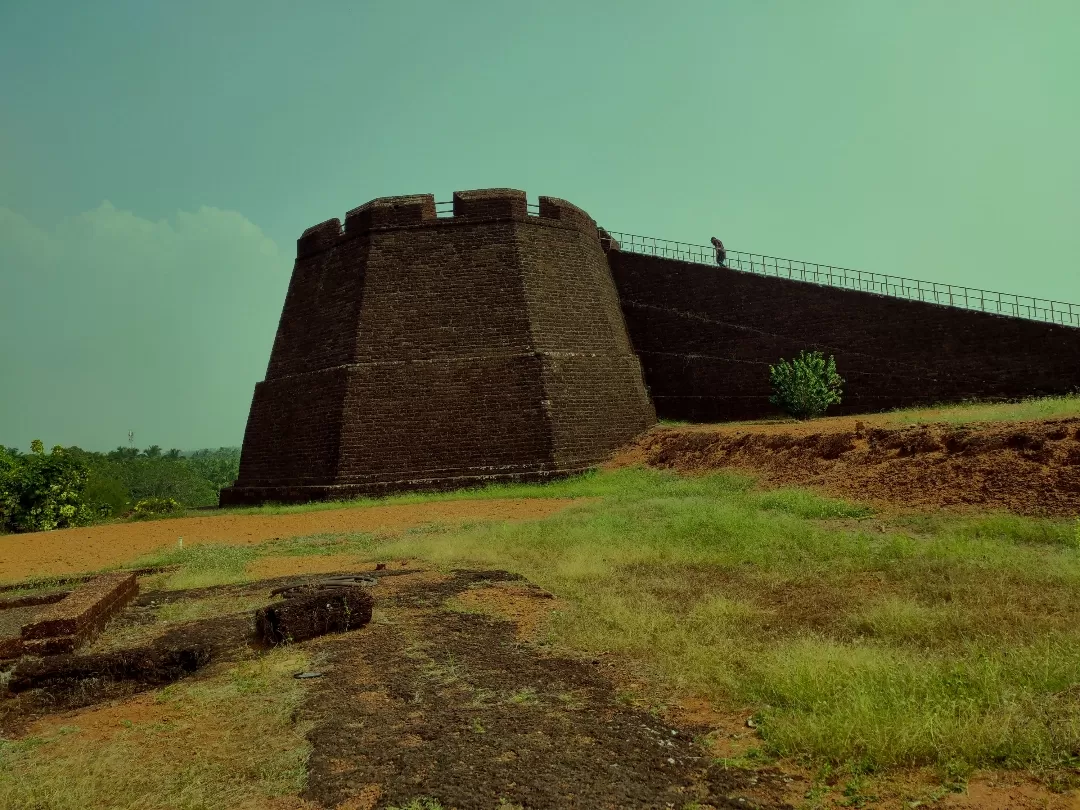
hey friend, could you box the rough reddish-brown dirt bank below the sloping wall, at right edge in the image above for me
[610,417,1080,516]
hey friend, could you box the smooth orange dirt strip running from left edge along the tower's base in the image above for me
[0,498,573,583]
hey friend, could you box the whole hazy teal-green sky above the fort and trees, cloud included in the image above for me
[0,0,1080,450]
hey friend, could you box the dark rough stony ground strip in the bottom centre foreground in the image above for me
[302,571,792,810]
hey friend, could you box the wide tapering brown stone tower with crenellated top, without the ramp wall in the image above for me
[220,189,656,505]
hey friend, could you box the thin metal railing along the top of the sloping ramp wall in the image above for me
[600,231,1080,327]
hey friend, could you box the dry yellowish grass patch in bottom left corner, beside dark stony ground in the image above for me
[0,648,311,810]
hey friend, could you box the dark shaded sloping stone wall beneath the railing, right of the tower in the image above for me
[608,249,1080,421]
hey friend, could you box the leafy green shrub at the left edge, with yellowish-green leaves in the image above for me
[0,438,94,531]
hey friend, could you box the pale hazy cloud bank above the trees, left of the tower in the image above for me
[0,202,291,448]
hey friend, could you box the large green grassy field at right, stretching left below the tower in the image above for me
[0,469,1080,807]
